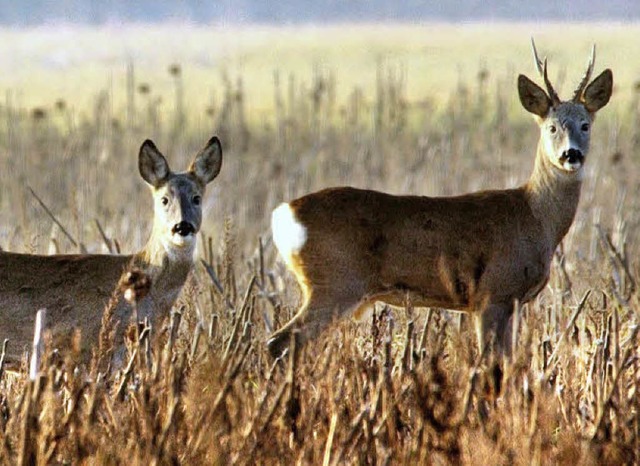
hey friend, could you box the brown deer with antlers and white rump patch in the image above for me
[267,42,613,356]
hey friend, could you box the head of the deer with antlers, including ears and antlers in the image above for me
[518,39,613,173]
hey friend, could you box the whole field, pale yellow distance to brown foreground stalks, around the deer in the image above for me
[0,24,640,465]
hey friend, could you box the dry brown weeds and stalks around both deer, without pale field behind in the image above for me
[0,39,640,464]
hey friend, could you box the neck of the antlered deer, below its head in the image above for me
[524,141,584,248]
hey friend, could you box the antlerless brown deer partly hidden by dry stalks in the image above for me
[0,137,222,363]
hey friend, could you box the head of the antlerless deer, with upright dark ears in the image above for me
[138,136,222,255]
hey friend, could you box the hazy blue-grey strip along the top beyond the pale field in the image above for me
[0,0,640,25]
